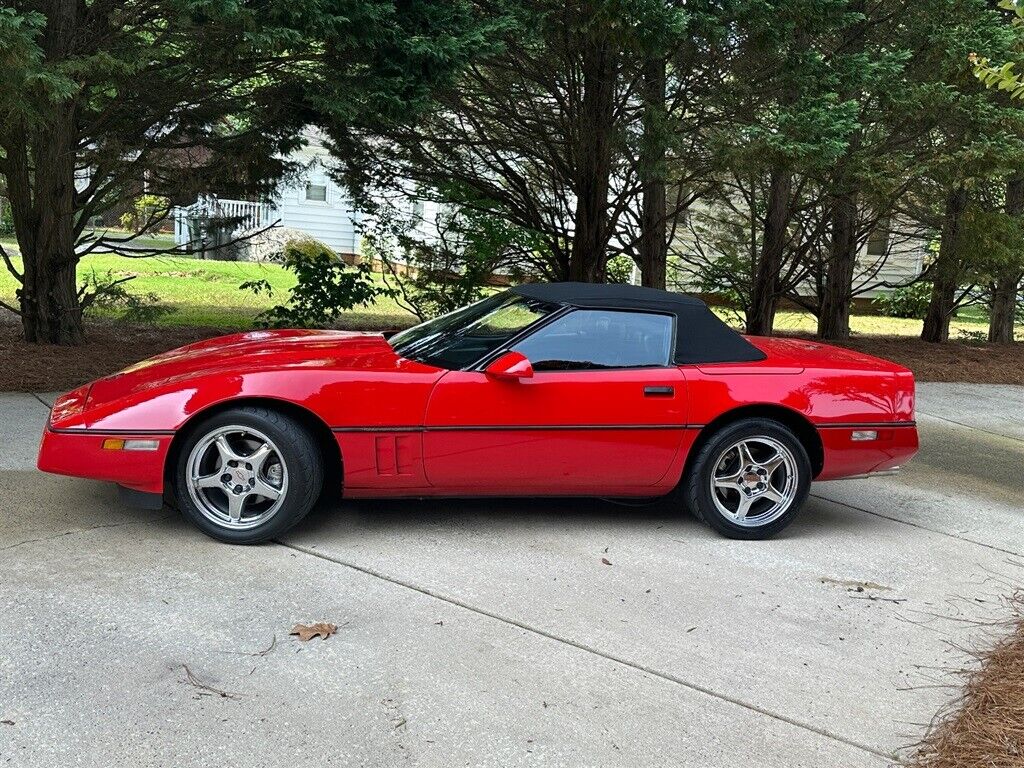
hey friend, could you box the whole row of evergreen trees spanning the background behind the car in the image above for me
[0,0,1024,343]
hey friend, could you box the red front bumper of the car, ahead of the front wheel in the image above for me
[36,426,174,494]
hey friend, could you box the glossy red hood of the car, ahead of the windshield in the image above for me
[86,331,413,407]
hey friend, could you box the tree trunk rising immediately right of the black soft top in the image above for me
[746,167,793,336]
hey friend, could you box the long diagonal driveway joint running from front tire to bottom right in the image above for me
[273,539,898,761]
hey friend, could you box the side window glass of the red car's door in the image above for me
[513,309,672,371]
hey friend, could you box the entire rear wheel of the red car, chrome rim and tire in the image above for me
[684,419,811,539]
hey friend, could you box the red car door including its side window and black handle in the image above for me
[423,308,687,495]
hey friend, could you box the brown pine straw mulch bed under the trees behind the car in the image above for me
[0,315,1024,392]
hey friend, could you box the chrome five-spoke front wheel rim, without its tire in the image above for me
[185,424,289,530]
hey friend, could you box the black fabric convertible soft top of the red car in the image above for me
[511,283,765,366]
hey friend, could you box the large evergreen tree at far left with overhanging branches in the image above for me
[0,0,497,344]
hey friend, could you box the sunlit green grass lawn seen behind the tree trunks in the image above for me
[0,239,1007,339]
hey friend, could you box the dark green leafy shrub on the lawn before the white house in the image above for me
[239,240,388,328]
